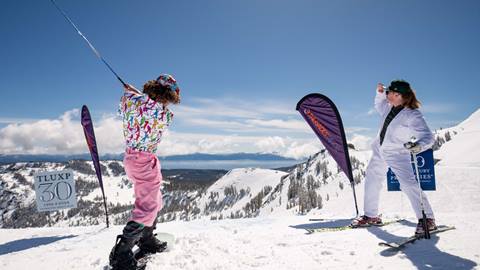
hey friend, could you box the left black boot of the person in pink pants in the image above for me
[109,221,145,270]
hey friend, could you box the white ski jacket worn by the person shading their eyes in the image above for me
[373,91,434,161]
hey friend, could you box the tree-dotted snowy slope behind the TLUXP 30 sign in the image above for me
[0,161,139,227]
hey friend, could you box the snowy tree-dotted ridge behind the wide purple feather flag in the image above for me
[261,149,371,216]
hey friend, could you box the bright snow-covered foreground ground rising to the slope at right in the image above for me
[0,108,480,270]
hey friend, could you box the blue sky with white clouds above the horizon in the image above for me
[0,0,480,157]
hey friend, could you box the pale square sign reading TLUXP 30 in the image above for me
[33,170,77,212]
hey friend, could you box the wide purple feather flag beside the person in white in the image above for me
[297,94,358,215]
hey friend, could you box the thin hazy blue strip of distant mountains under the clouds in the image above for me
[0,153,295,164]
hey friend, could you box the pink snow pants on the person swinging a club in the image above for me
[123,148,162,227]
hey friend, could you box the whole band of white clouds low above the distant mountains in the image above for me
[0,104,372,159]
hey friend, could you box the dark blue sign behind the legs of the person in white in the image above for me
[387,149,436,191]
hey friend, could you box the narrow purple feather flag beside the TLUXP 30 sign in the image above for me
[81,105,109,228]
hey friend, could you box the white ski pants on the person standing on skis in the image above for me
[363,142,434,219]
